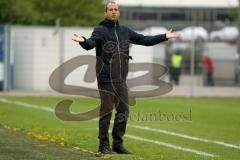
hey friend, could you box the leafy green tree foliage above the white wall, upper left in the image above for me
[0,0,104,26]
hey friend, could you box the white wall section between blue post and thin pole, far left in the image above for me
[11,27,59,91]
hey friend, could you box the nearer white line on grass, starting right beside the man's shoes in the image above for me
[125,134,218,157]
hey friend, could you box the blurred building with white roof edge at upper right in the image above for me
[116,0,238,30]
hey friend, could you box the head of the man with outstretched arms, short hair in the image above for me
[105,3,120,22]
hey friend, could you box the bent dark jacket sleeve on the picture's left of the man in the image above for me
[79,27,101,50]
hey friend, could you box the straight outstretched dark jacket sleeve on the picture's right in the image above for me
[128,28,168,46]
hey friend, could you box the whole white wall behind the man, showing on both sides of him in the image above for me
[11,27,164,91]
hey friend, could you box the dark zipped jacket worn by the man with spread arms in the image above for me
[79,19,167,83]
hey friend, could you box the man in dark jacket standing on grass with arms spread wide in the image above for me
[72,2,179,154]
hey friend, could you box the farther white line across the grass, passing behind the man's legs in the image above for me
[0,98,236,155]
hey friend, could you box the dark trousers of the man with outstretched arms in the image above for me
[98,82,129,146]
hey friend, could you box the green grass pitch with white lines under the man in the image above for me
[0,96,240,160]
